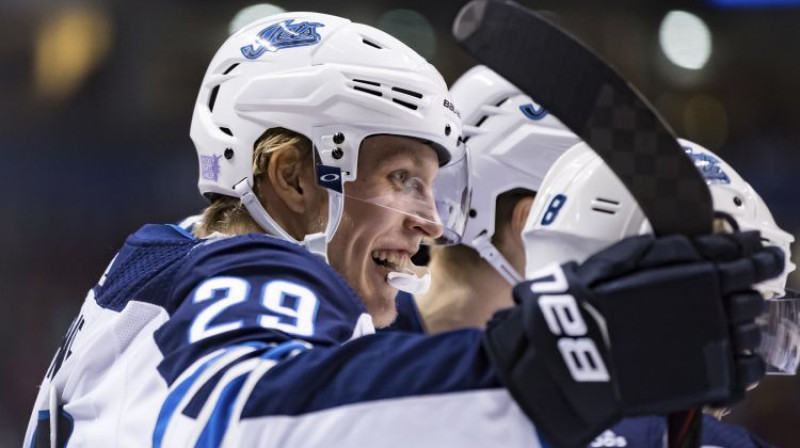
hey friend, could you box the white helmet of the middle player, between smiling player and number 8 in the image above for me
[450,65,580,284]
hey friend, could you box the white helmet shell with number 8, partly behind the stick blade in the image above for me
[523,140,795,298]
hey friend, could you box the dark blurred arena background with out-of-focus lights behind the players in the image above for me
[0,0,800,447]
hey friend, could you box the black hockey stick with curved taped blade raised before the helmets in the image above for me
[453,0,713,448]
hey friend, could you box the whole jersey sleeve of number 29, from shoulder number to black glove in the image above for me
[153,236,539,448]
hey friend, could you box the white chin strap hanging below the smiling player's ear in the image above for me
[233,179,342,263]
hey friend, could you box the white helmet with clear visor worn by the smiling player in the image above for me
[191,12,466,255]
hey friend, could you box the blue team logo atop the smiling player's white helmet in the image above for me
[242,19,325,59]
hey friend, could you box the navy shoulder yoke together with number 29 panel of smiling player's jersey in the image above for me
[88,224,366,381]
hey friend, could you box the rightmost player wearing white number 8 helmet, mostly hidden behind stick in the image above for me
[522,140,800,448]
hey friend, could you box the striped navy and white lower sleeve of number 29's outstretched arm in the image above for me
[159,330,552,448]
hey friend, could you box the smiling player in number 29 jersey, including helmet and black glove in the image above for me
[26,13,783,448]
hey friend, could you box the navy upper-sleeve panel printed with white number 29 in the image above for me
[154,229,366,382]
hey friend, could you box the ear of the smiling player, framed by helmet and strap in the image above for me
[267,145,313,214]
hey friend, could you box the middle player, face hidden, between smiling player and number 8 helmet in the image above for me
[406,66,580,333]
